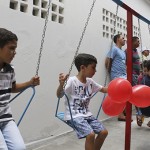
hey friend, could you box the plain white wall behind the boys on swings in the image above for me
[0,0,149,143]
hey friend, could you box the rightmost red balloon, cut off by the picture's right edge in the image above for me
[129,85,150,107]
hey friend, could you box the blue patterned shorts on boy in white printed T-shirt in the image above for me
[67,116,106,139]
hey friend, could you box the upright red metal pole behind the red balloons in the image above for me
[125,10,132,150]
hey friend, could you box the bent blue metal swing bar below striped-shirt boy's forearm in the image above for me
[10,86,35,126]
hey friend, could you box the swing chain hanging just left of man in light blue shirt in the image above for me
[104,5,119,87]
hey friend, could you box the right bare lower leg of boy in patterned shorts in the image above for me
[94,130,108,150]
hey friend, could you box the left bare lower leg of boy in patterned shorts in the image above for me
[85,132,95,150]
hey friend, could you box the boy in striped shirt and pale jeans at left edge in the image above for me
[0,28,40,150]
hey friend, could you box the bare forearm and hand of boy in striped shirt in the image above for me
[11,77,40,93]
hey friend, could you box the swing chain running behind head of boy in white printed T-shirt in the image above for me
[63,0,96,89]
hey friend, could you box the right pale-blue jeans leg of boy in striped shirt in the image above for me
[2,120,26,150]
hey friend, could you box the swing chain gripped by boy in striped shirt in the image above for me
[36,0,51,76]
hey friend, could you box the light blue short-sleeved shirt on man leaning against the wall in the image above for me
[107,46,127,80]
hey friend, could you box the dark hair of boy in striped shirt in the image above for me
[0,28,18,48]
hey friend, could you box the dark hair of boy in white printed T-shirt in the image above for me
[75,53,97,71]
